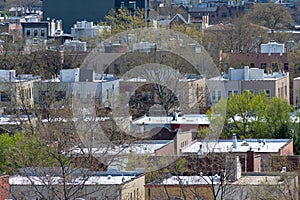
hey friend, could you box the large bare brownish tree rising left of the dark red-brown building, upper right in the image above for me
[203,17,269,71]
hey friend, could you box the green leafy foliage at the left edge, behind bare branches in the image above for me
[0,133,59,174]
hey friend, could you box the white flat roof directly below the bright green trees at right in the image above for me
[182,139,291,154]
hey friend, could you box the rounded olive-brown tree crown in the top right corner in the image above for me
[246,3,293,29]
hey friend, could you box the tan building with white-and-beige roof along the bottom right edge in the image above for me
[145,163,298,200]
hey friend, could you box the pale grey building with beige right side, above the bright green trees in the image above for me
[207,66,290,104]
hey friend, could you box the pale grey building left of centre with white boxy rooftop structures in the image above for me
[34,68,119,107]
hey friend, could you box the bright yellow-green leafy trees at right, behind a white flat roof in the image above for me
[211,91,293,138]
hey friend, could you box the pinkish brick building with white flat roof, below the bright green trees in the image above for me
[182,136,294,172]
